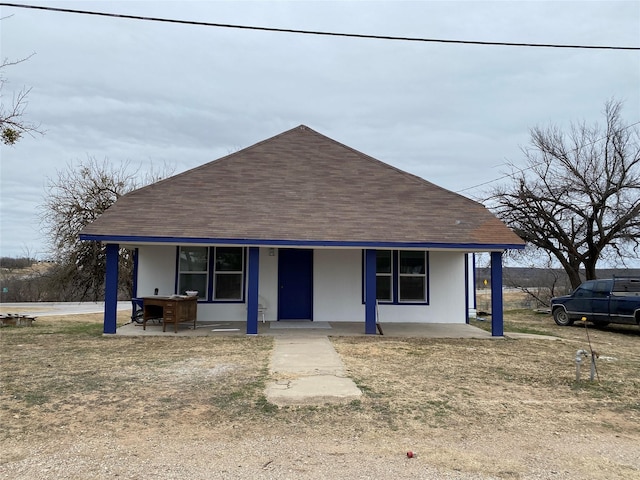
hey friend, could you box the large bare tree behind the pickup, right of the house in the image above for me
[490,100,640,288]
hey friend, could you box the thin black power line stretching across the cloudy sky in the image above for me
[0,2,640,50]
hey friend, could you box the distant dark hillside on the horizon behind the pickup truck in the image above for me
[476,267,640,288]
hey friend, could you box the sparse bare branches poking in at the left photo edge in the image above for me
[0,53,42,145]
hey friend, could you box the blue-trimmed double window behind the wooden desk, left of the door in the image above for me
[177,246,245,302]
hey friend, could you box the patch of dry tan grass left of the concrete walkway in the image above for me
[0,315,272,439]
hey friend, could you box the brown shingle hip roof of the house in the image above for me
[82,125,524,246]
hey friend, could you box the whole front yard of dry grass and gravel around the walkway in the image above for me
[0,311,640,480]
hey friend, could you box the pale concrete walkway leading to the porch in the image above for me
[265,334,362,406]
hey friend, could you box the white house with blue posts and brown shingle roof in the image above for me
[80,125,524,336]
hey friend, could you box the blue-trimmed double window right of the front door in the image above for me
[363,250,429,304]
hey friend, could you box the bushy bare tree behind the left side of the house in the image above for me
[41,157,174,301]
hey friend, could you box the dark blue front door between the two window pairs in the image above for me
[278,249,313,320]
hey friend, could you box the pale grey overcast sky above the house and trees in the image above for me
[0,1,640,258]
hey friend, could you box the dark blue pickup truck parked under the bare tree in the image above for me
[551,277,640,327]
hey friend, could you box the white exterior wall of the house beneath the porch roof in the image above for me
[138,245,467,324]
